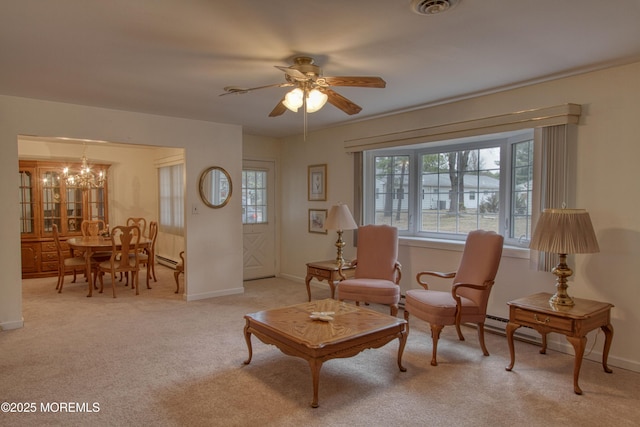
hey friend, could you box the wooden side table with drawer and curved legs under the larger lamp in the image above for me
[506,292,613,394]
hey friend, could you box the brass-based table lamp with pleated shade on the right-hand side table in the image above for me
[529,209,600,306]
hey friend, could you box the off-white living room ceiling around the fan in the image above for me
[0,0,640,137]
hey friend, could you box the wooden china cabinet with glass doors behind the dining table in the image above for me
[19,160,109,278]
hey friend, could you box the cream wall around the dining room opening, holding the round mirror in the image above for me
[0,96,243,329]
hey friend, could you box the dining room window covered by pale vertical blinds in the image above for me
[158,164,184,236]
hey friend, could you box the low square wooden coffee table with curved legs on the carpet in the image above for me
[244,299,408,408]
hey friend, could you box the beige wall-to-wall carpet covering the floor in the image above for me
[0,266,640,426]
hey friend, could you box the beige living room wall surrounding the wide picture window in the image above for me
[281,63,640,371]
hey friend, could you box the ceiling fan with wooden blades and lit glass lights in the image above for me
[220,56,386,117]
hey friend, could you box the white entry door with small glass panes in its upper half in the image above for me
[241,160,276,280]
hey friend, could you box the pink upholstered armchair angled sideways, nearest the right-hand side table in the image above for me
[404,230,504,366]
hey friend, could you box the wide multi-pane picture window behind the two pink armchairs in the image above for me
[363,130,533,244]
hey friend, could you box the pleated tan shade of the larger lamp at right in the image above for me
[529,209,600,254]
